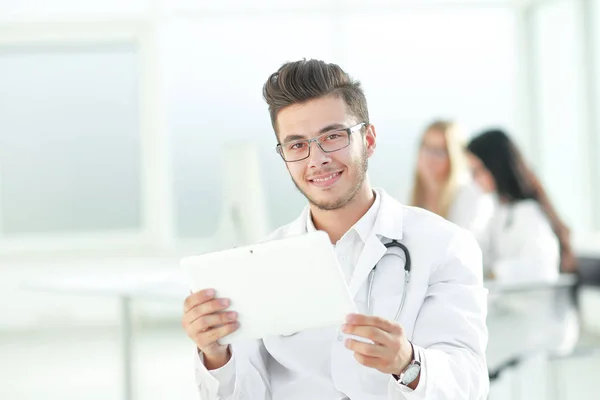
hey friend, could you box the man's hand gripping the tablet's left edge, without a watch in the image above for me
[181,289,239,370]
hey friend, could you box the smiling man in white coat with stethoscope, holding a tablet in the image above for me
[183,60,489,400]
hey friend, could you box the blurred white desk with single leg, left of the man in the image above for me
[24,267,190,400]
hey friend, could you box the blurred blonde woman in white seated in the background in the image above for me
[410,120,493,237]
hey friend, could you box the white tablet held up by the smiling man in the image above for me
[181,232,356,344]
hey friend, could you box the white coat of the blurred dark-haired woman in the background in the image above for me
[481,200,579,360]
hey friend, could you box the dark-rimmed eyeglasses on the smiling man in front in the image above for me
[276,122,367,162]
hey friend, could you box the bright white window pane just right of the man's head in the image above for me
[342,8,516,201]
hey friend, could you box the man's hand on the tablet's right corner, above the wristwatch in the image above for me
[342,314,418,382]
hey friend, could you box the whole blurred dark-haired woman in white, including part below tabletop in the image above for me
[467,129,579,391]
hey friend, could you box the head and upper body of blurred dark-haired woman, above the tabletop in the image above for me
[467,130,575,281]
